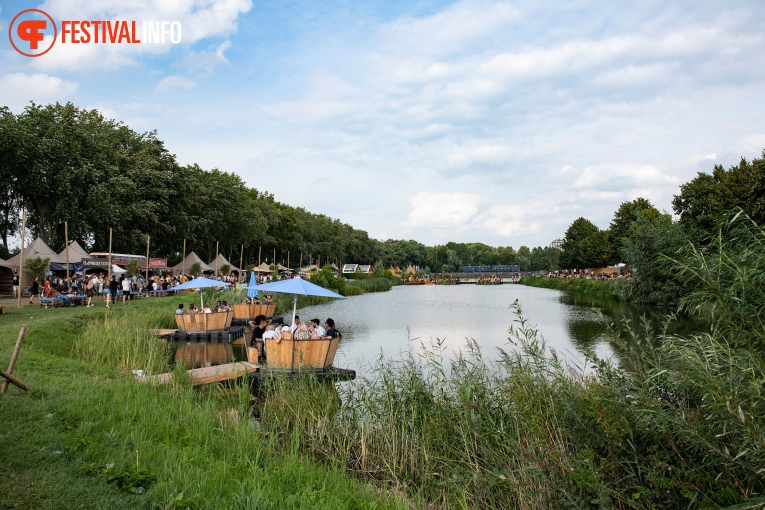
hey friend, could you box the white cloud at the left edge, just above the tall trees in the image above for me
[0,73,78,112]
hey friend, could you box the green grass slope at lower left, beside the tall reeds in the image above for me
[0,298,405,509]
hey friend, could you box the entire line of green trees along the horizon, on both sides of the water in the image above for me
[0,103,765,284]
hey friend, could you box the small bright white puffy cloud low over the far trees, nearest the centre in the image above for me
[404,191,484,228]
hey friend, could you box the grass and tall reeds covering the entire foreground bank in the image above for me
[0,289,765,509]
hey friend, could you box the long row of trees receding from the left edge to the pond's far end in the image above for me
[0,103,568,272]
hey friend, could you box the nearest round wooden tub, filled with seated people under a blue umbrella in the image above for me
[266,333,342,370]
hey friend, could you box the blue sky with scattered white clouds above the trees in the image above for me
[0,0,765,248]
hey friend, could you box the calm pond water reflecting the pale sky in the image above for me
[298,285,704,372]
